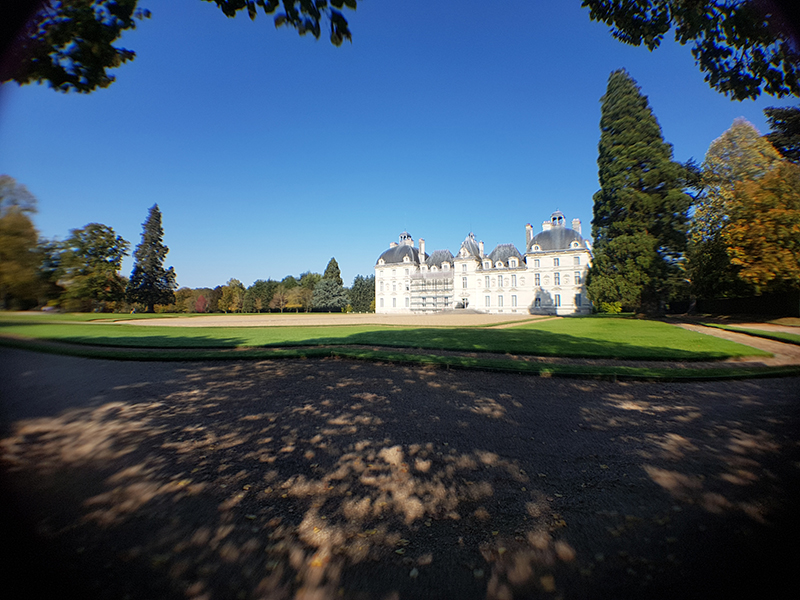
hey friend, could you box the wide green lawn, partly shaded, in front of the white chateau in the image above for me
[0,315,769,361]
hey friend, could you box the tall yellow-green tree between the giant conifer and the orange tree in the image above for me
[687,119,780,298]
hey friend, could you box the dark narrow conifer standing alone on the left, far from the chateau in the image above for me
[126,204,178,312]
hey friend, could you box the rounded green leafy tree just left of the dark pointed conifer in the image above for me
[59,223,130,310]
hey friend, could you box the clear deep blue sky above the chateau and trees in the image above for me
[0,0,797,287]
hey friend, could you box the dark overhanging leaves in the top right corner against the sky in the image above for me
[581,0,800,100]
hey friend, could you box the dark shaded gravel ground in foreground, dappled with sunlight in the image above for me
[0,349,800,600]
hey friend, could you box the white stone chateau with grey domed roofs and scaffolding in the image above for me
[375,211,592,315]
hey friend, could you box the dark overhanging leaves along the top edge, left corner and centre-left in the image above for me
[0,0,358,93]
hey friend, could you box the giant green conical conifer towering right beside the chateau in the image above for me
[588,69,691,313]
